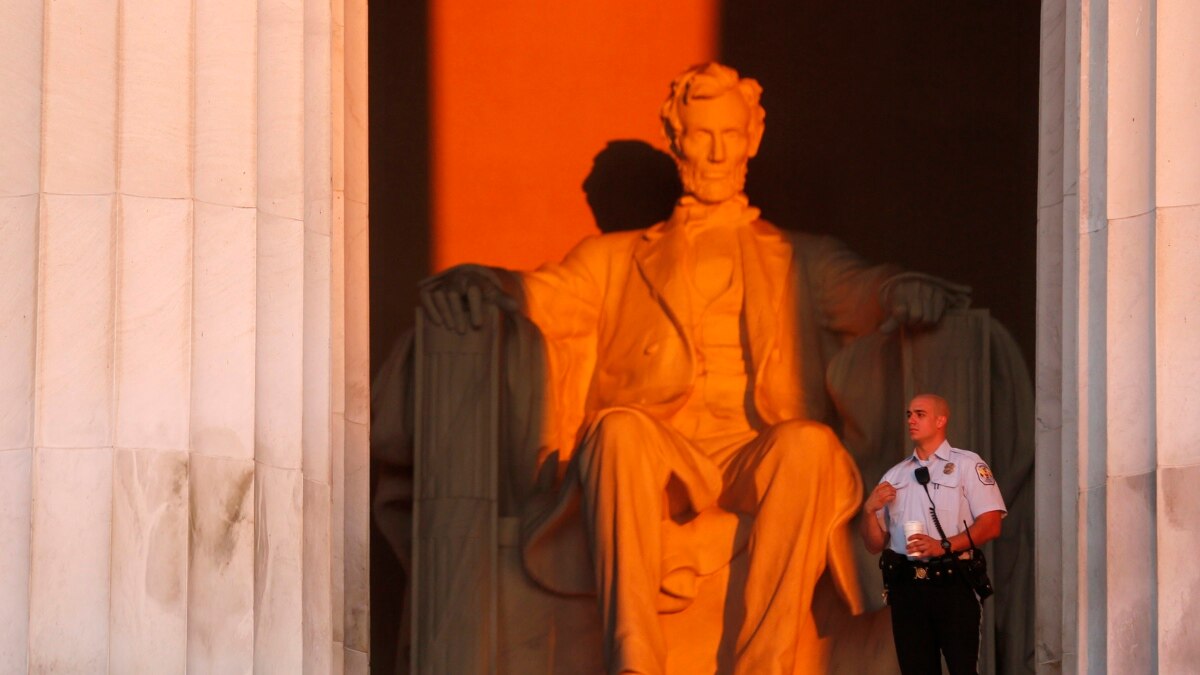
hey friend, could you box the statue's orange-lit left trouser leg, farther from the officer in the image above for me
[576,408,672,675]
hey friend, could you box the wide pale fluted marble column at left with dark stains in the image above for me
[0,0,368,673]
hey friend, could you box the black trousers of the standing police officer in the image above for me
[888,583,979,675]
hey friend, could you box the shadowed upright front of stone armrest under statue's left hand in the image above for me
[412,309,502,674]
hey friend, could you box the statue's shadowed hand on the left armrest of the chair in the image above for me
[420,264,518,334]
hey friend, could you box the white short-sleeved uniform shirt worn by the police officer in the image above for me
[875,441,1008,555]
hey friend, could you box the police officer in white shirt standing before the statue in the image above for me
[859,394,1008,675]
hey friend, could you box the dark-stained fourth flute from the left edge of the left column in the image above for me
[187,0,258,673]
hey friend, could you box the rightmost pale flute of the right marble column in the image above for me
[1153,0,1200,673]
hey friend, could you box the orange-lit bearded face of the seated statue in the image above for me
[677,90,752,204]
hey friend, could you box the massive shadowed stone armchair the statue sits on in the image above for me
[372,310,1033,674]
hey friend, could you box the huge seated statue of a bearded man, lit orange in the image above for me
[421,64,965,674]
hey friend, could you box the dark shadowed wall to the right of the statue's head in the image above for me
[720,0,1040,364]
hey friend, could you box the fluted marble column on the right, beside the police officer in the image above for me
[1037,0,1200,673]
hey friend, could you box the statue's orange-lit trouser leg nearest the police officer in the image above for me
[722,420,858,675]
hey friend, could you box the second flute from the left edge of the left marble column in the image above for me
[28,0,120,673]
